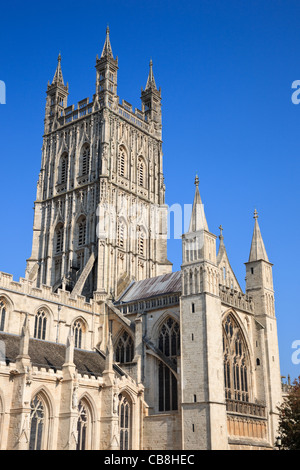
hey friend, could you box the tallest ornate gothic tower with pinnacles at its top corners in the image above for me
[26,28,171,297]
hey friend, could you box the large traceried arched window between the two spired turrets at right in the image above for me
[223,314,250,402]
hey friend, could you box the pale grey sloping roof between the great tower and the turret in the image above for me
[118,271,181,303]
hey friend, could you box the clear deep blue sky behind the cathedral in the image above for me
[0,0,300,378]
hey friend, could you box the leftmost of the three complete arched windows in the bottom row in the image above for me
[29,394,48,450]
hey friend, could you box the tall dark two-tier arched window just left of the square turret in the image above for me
[158,317,180,411]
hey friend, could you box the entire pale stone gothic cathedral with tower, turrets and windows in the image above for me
[0,29,282,451]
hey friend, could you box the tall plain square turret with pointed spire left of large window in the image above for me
[180,177,228,450]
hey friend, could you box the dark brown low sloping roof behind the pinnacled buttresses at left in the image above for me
[0,333,116,377]
